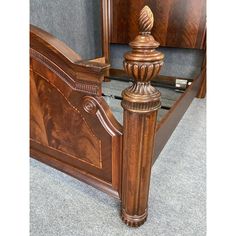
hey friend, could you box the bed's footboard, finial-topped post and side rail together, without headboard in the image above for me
[30,6,205,227]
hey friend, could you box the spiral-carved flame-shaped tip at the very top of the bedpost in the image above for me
[139,6,154,34]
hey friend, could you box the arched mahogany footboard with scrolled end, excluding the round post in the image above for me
[30,26,122,197]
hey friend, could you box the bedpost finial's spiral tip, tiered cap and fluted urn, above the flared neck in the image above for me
[124,6,164,83]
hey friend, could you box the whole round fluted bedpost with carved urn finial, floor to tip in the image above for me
[121,6,164,227]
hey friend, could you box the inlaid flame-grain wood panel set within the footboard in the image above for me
[31,70,102,168]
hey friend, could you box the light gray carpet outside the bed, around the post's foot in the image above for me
[30,99,206,236]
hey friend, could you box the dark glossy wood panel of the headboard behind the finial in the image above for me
[110,0,206,49]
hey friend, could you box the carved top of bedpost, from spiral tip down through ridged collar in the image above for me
[122,6,164,112]
